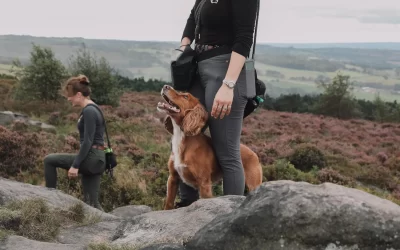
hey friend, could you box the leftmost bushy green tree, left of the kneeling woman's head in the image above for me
[11,44,67,102]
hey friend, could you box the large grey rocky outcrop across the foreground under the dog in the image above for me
[0,179,400,250]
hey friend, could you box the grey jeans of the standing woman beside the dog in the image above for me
[179,54,247,201]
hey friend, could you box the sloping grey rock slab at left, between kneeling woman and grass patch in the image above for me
[0,177,118,220]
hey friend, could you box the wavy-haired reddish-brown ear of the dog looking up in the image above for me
[182,104,208,136]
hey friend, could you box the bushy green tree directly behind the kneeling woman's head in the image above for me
[69,46,123,107]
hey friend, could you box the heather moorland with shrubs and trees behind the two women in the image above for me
[0,44,400,211]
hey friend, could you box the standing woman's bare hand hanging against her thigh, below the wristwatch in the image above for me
[211,84,233,119]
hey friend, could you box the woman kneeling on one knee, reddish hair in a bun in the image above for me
[44,75,105,210]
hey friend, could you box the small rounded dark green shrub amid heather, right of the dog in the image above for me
[288,144,326,172]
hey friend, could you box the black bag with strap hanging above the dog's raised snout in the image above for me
[170,0,207,91]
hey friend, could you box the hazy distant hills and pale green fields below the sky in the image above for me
[0,35,400,100]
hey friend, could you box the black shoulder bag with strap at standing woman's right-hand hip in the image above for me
[243,0,266,118]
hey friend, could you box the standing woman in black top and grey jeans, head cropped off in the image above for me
[177,0,258,206]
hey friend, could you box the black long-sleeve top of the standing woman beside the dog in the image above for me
[182,0,257,57]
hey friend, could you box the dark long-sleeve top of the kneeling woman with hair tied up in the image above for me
[72,104,105,168]
